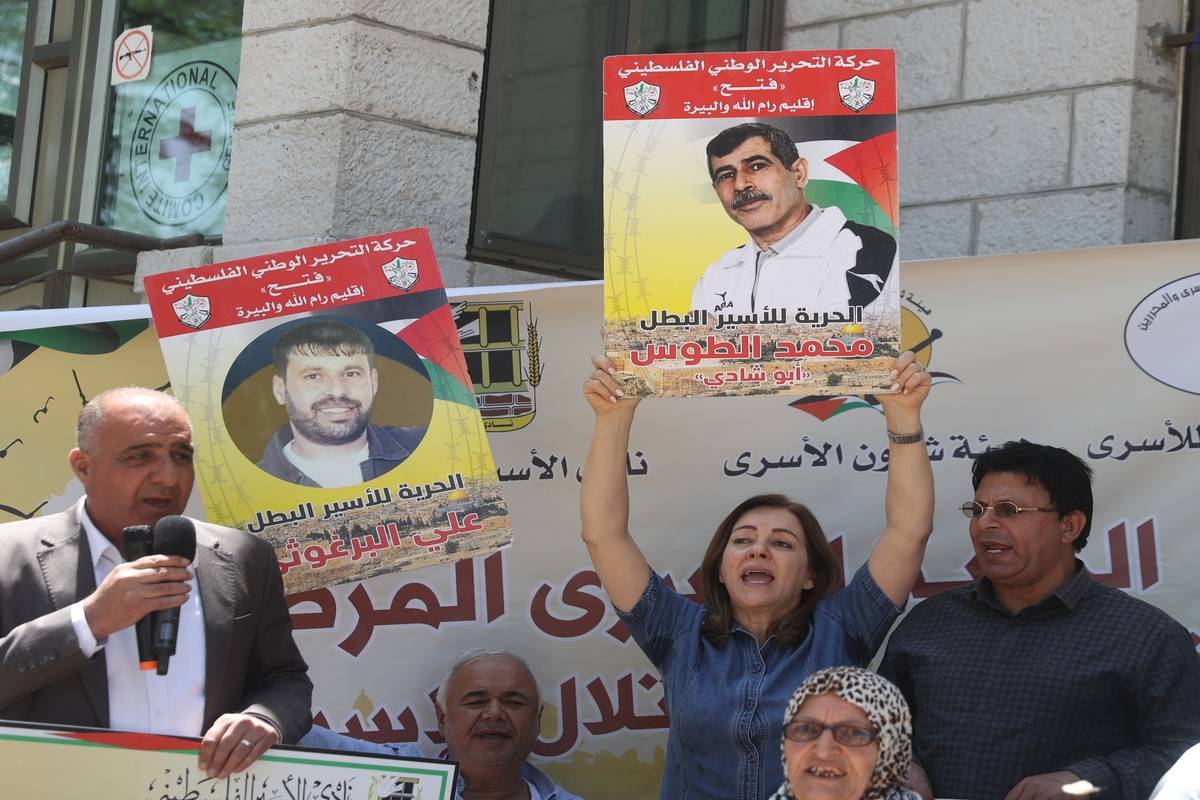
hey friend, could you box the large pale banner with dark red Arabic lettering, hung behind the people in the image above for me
[0,241,1200,800]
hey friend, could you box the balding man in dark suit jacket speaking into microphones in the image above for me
[0,387,312,777]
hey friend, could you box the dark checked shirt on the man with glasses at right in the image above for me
[880,563,1200,800]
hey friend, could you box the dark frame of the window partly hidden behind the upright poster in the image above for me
[467,0,784,279]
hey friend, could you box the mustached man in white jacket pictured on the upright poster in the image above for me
[691,122,900,321]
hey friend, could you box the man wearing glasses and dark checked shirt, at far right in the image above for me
[880,441,1200,800]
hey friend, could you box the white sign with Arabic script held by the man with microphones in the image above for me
[0,722,458,800]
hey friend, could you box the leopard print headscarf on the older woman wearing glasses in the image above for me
[770,667,919,800]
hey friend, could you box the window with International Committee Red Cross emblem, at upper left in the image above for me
[0,0,242,307]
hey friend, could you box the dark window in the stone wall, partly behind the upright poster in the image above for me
[467,0,782,278]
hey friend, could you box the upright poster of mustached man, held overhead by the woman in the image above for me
[604,49,900,397]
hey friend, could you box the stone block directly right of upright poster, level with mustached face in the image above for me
[899,95,1070,204]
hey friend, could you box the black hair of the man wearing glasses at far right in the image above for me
[971,441,1092,553]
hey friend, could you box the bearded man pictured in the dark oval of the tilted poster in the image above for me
[258,319,425,487]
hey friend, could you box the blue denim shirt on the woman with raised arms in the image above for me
[619,565,902,800]
